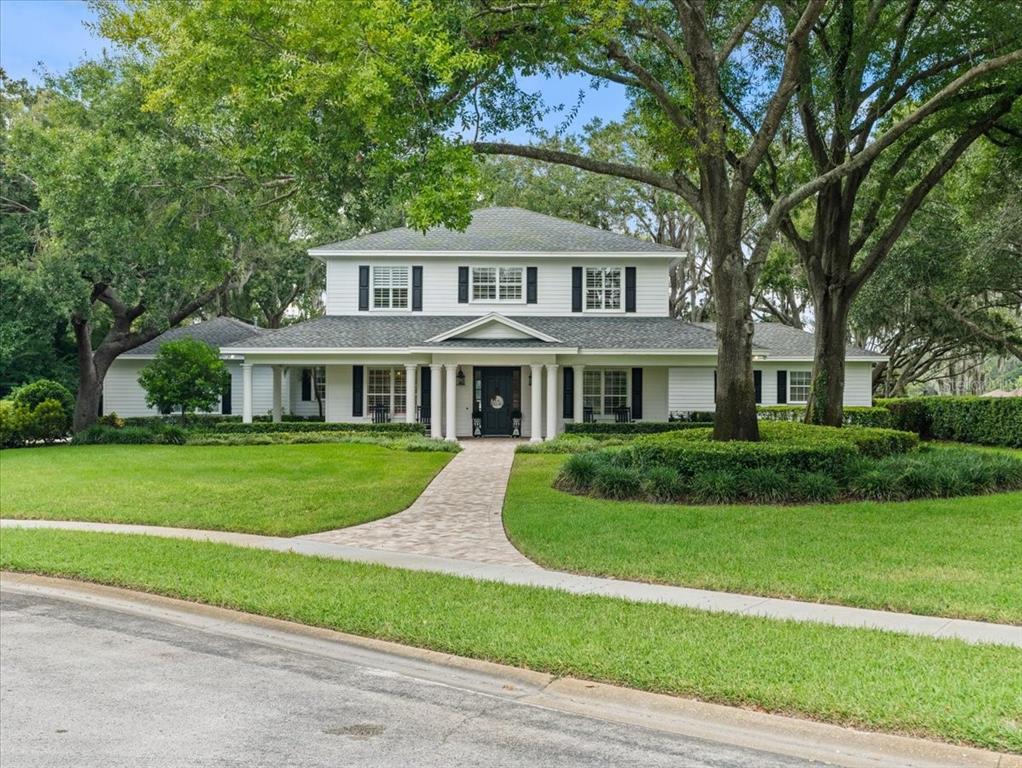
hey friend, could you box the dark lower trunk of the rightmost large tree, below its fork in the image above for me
[805,285,851,426]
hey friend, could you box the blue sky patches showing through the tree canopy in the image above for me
[0,0,624,141]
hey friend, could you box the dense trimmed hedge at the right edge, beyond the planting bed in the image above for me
[877,396,1022,448]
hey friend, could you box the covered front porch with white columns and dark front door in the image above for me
[235,349,668,442]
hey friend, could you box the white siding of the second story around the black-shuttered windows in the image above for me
[326,255,670,317]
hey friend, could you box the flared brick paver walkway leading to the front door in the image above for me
[299,439,538,568]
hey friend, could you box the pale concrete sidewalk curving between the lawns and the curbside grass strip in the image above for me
[0,519,1022,647]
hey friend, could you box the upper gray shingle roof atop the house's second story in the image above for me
[309,208,680,257]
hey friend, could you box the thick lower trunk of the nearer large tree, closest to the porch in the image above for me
[712,253,759,441]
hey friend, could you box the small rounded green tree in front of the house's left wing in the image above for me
[138,338,231,422]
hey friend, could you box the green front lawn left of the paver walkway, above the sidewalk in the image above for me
[0,444,453,536]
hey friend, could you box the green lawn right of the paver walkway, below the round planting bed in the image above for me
[504,454,1022,624]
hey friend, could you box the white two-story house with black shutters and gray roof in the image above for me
[105,208,882,440]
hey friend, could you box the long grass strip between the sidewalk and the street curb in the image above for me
[0,529,1022,752]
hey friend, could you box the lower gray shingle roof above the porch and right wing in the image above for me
[223,315,881,360]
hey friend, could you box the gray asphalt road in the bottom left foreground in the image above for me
[0,592,816,768]
